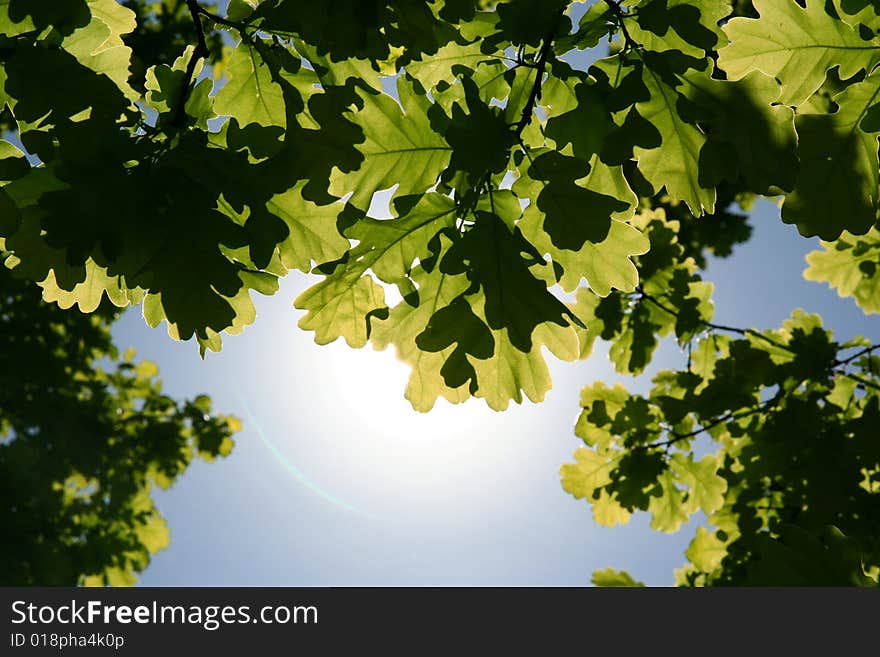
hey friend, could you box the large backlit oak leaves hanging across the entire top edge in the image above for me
[0,0,878,410]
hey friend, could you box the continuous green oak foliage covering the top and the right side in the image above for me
[0,0,880,584]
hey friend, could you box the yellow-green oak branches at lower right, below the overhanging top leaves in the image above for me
[561,256,880,586]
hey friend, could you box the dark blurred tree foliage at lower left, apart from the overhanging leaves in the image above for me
[0,262,240,586]
